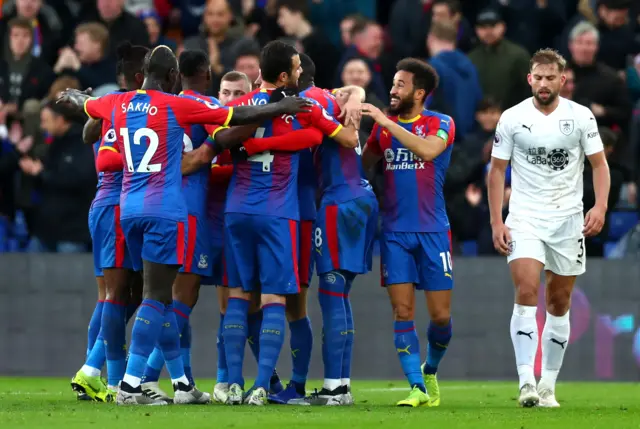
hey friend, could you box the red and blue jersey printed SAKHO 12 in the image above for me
[85,90,233,221]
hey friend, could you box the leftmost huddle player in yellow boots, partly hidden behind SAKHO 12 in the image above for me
[71,43,149,401]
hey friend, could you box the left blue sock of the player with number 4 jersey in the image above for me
[222,298,249,388]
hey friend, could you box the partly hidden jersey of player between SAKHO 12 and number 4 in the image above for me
[180,90,221,216]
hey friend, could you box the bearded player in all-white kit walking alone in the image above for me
[488,49,610,407]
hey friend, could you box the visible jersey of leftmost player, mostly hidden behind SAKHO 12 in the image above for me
[92,120,123,207]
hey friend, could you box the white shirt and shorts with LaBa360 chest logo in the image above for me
[491,97,604,276]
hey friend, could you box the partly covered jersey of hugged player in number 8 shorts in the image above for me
[305,87,373,204]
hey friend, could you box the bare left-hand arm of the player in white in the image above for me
[487,157,511,256]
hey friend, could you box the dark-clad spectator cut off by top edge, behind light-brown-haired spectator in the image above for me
[80,0,149,58]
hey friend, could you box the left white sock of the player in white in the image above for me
[511,304,538,388]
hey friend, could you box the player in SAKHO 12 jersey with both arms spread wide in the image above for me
[60,46,308,405]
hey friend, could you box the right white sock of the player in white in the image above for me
[540,311,571,390]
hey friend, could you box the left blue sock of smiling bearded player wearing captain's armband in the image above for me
[393,320,426,393]
